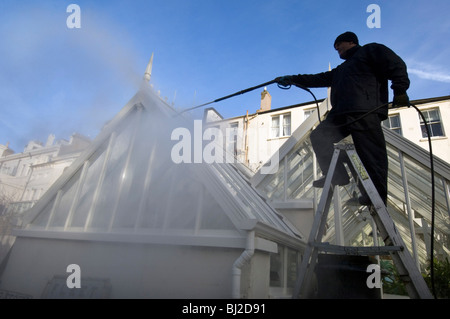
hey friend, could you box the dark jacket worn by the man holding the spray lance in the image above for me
[292,43,410,119]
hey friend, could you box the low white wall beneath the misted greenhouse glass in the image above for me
[0,237,250,299]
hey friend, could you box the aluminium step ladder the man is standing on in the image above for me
[292,143,433,299]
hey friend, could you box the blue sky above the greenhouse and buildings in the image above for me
[0,0,450,152]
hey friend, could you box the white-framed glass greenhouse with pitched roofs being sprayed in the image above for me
[0,83,450,298]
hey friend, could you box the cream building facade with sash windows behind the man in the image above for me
[204,89,450,172]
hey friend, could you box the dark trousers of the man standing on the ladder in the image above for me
[310,113,388,203]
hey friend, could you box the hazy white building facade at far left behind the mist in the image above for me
[0,133,90,262]
